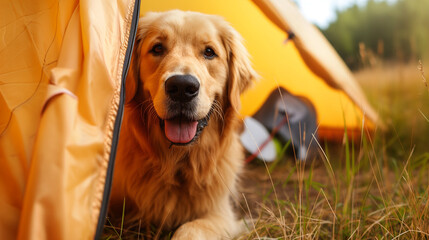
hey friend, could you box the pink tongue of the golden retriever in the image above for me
[165,120,198,143]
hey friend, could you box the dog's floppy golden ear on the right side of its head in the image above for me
[223,25,258,111]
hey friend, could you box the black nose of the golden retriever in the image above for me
[165,75,200,102]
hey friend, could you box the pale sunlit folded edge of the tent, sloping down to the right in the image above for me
[252,0,383,125]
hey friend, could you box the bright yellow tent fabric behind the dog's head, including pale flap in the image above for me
[141,0,378,138]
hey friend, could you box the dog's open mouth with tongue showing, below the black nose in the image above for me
[160,111,211,146]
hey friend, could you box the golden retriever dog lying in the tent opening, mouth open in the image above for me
[111,10,256,239]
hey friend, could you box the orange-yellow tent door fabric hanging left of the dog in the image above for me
[0,0,137,239]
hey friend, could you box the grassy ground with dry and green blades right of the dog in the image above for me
[104,64,429,240]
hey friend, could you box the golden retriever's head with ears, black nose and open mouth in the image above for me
[126,10,256,145]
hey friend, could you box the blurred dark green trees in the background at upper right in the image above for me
[321,0,429,70]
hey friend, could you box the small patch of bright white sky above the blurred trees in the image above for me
[295,0,367,28]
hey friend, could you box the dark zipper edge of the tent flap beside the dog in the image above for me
[94,0,140,240]
